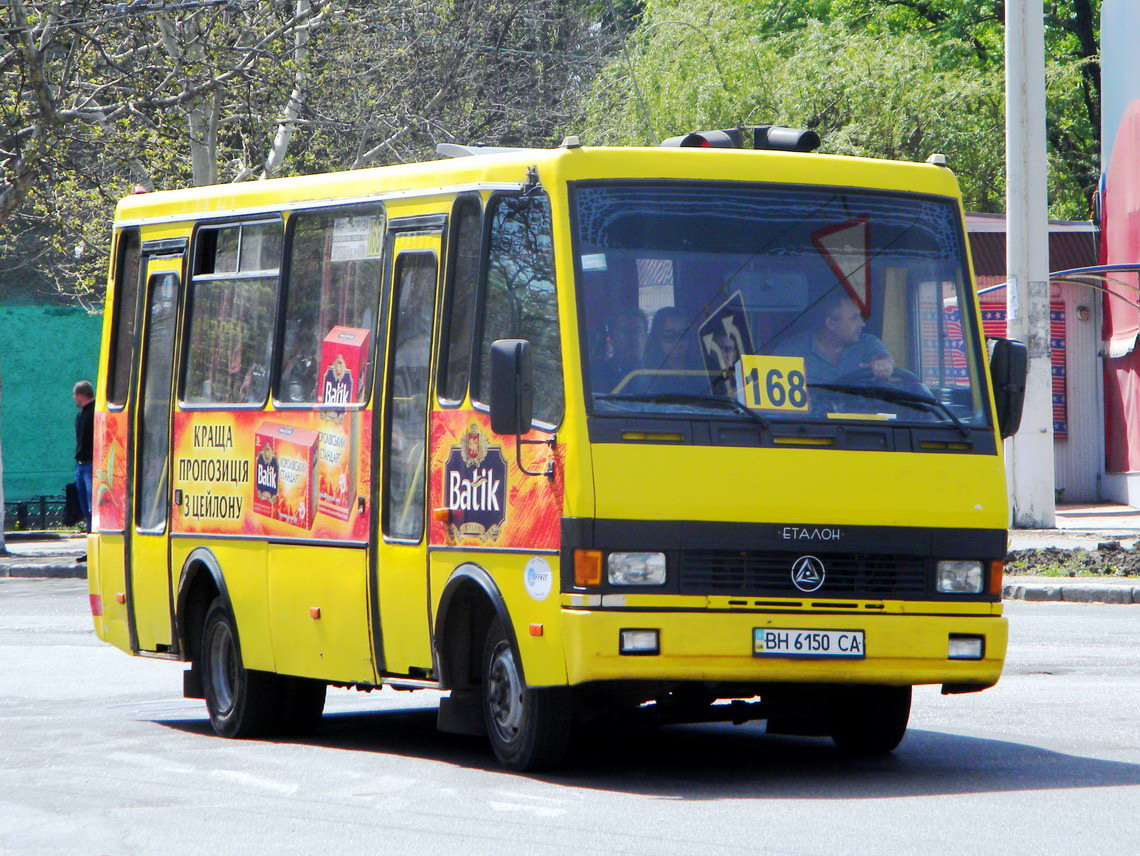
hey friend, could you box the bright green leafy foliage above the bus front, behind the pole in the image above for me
[585,0,1099,219]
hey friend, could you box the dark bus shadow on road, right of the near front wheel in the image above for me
[562,725,1140,800]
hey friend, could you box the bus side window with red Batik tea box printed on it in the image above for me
[275,204,384,403]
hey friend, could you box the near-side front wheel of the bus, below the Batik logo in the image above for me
[480,619,573,772]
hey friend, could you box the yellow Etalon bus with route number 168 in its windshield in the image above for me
[88,128,1024,769]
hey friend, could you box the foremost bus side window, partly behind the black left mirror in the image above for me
[473,195,563,426]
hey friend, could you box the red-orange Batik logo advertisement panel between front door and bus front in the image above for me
[430,410,563,549]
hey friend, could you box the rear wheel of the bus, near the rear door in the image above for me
[198,598,282,737]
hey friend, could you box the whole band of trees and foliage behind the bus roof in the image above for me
[0,0,1100,305]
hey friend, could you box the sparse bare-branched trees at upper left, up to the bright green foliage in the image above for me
[0,0,629,305]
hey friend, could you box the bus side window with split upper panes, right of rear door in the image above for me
[182,219,282,405]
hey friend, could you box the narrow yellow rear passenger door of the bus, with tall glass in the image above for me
[127,250,185,652]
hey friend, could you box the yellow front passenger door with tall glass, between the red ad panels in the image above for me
[374,232,442,677]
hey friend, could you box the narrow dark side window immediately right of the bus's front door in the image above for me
[438,196,483,406]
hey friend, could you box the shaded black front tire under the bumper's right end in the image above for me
[828,686,911,756]
